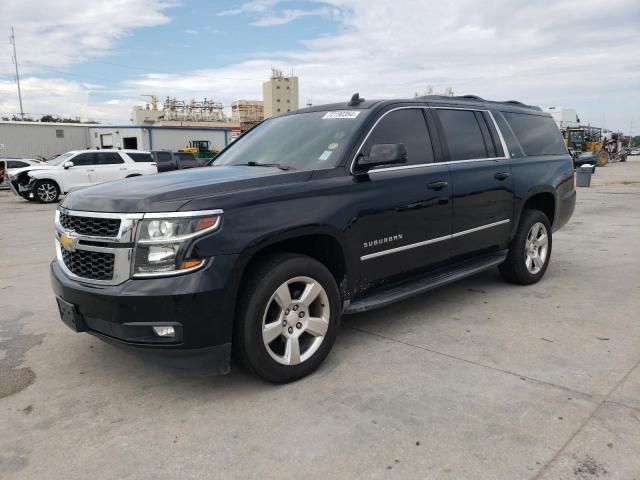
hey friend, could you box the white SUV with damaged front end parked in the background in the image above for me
[9,150,158,203]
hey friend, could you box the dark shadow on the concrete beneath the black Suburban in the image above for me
[80,270,510,397]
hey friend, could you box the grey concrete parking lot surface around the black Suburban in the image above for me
[0,157,640,480]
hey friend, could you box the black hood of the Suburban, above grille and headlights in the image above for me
[62,166,311,213]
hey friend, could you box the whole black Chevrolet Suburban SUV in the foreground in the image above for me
[51,95,576,382]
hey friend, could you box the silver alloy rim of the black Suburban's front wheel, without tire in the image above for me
[262,277,331,365]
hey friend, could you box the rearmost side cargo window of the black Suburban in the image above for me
[503,113,567,155]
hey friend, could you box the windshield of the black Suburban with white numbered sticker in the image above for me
[213,110,365,170]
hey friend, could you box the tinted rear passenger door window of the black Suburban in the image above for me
[435,110,493,160]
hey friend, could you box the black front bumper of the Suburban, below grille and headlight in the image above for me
[51,255,237,374]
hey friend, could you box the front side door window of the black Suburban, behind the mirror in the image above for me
[362,108,433,165]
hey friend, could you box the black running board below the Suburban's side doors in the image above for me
[342,250,508,315]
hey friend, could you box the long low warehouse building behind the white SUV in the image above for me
[0,121,232,158]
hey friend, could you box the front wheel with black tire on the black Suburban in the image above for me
[234,254,342,383]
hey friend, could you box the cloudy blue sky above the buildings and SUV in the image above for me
[0,0,640,135]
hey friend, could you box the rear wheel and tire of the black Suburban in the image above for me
[499,210,552,285]
